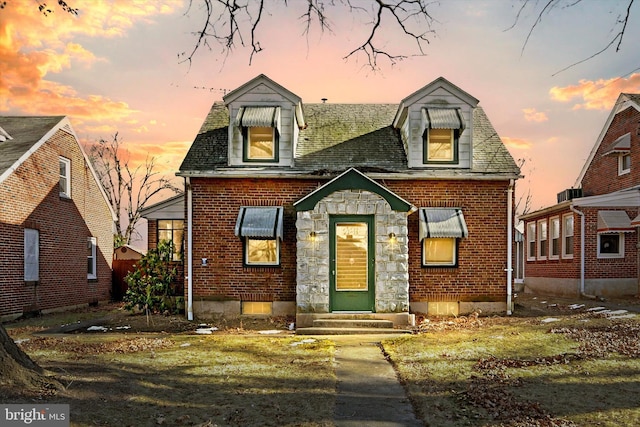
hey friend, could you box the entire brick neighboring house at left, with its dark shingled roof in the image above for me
[0,117,114,320]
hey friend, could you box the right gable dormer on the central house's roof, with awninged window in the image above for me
[393,77,478,169]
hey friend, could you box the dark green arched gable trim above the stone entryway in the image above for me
[293,168,413,212]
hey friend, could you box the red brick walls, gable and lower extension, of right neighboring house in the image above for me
[523,94,640,296]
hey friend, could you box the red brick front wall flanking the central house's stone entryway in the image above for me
[191,178,508,301]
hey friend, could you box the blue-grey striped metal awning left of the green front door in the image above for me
[235,206,284,240]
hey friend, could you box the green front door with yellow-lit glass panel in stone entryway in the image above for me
[329,215,375,312]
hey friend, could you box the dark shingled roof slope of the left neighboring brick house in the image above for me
[0,116,64,181]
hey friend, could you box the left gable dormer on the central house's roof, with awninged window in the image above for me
[223,74,304,167]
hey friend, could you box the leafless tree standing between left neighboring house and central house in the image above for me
[89,132,180,246]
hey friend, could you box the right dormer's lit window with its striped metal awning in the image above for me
[422,108,464,164]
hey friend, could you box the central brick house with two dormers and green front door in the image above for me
[178,75,520,327]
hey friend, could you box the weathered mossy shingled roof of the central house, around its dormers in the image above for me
[180,102,520,175]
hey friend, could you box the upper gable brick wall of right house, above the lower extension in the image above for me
[582,108,640,196]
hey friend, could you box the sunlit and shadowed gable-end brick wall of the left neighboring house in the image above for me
[0,131,113,317]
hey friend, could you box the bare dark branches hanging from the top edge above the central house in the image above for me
[179,0,434,70]
